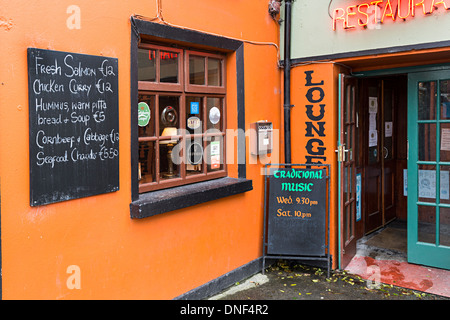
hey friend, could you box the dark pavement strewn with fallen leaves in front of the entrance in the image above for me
[209,260,450,301]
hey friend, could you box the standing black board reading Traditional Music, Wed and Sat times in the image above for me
[266,168,327,256]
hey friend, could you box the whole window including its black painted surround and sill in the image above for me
[130,17,253,219]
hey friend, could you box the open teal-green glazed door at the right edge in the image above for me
[408,69,450,269]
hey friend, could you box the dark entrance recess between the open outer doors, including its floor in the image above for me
[355,75,408,261]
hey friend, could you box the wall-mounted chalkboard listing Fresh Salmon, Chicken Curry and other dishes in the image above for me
[28,48,119,206]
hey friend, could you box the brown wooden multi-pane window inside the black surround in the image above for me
[137,44,227,193]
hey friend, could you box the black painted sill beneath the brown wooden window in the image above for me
[130,177,253,219]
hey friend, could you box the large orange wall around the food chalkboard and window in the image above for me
[0,0,282,299]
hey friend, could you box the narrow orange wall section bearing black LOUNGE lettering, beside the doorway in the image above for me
[291,63,339,268]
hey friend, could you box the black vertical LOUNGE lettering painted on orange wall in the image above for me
[305,71,327,163]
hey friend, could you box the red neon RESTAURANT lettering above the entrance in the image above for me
[332,0,450,31]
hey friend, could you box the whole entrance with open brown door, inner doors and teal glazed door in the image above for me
[337,68,450,270]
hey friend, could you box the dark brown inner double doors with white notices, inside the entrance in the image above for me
[362,78,399,234]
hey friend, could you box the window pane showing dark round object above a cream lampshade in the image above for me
[159,96,180,136]
